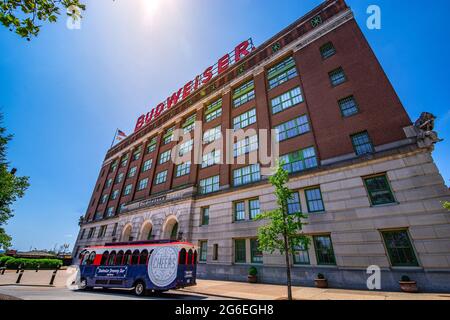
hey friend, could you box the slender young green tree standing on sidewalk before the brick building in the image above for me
[257,164,310,300]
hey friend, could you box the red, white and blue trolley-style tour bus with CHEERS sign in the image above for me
[78,240,197,296]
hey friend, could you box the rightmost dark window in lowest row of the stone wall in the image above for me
[382,230,419,267]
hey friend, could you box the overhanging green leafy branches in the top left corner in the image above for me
[0,0,86,40]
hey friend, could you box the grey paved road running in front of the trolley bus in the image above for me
[0,286,230,300]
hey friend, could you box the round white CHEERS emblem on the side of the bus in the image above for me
[148,247,178,288]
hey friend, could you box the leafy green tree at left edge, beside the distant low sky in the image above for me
[0,114,29,248]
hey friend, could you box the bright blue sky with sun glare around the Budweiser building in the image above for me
[0,0,450,250]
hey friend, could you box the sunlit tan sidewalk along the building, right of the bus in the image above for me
[179,280,450,300]
